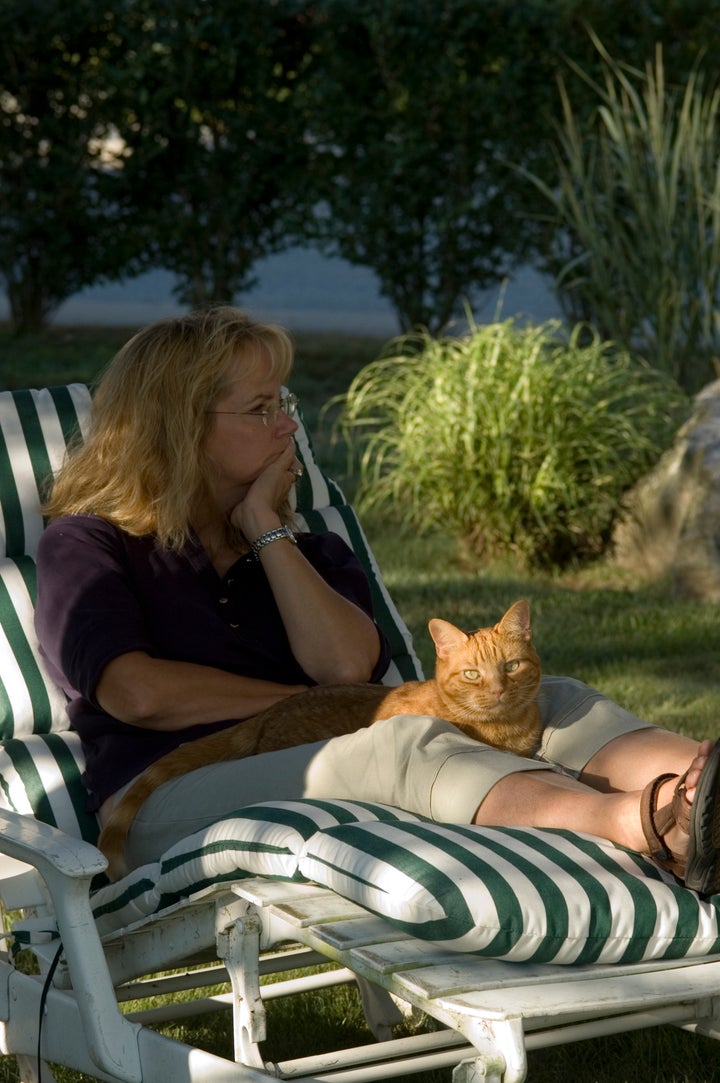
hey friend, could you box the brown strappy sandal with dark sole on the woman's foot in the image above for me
[640,741,720,895]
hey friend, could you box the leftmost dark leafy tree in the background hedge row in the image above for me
[0,0,144,330]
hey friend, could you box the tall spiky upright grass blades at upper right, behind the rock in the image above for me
[528,47,720,393]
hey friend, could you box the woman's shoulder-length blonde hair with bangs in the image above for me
[43,305,292,549]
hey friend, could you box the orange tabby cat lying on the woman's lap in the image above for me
[99,601,540,877]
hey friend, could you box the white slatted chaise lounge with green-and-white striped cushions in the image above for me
[0,384,720,1083]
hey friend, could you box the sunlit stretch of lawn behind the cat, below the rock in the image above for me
[365,517,720,740]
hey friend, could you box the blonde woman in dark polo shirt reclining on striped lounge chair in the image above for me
[36,306,720,892]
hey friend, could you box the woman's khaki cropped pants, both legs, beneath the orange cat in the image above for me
[115,677,650,865]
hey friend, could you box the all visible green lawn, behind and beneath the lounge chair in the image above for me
[0,326,720,1083]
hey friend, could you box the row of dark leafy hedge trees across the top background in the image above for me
[9,0,720,337]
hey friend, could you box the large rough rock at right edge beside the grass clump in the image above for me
[613,380,720,602]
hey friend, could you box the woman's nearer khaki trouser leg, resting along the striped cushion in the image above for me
[119,715,549,865]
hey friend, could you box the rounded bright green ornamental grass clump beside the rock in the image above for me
[339,319,689,566]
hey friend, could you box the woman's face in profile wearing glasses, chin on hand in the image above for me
[205,353,298,510]
